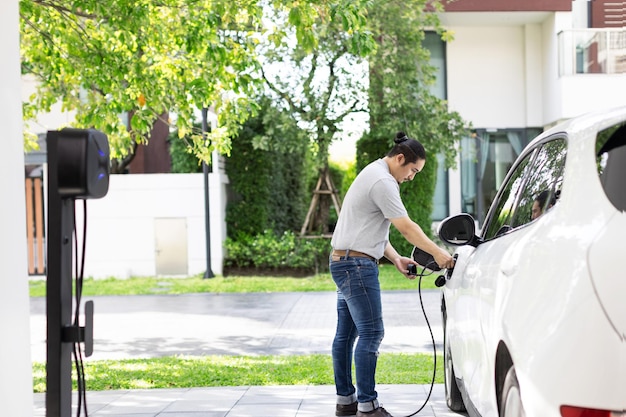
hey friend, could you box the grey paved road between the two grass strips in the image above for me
[31,290,443,361]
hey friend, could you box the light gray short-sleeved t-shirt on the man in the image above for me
[331,159,408,259]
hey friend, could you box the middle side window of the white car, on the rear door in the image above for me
[510,138,567,228]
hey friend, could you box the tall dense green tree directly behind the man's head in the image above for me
[357,0,468,254]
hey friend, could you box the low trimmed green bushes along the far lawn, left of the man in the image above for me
[224,230,330,272]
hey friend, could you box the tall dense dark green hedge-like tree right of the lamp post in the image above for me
[226,99,310,239]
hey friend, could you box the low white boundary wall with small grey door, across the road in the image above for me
[77,173,226,278]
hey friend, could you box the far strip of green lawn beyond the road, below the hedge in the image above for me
[30,264,438,297]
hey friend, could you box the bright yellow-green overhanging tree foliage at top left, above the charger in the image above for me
[20,0,368,171]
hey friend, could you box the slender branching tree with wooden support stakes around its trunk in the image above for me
[258,8,372,234]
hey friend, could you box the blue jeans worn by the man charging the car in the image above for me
[330,257,385,408]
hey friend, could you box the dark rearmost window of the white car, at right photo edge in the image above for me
[596,123,626,211]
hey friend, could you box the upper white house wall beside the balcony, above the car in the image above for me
[443,6,626,129]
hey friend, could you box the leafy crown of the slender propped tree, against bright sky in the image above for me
[259,2,371,171]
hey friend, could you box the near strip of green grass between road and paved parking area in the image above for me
[33,353,443,392]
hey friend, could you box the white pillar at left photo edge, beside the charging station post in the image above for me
[0,0,33,417]
